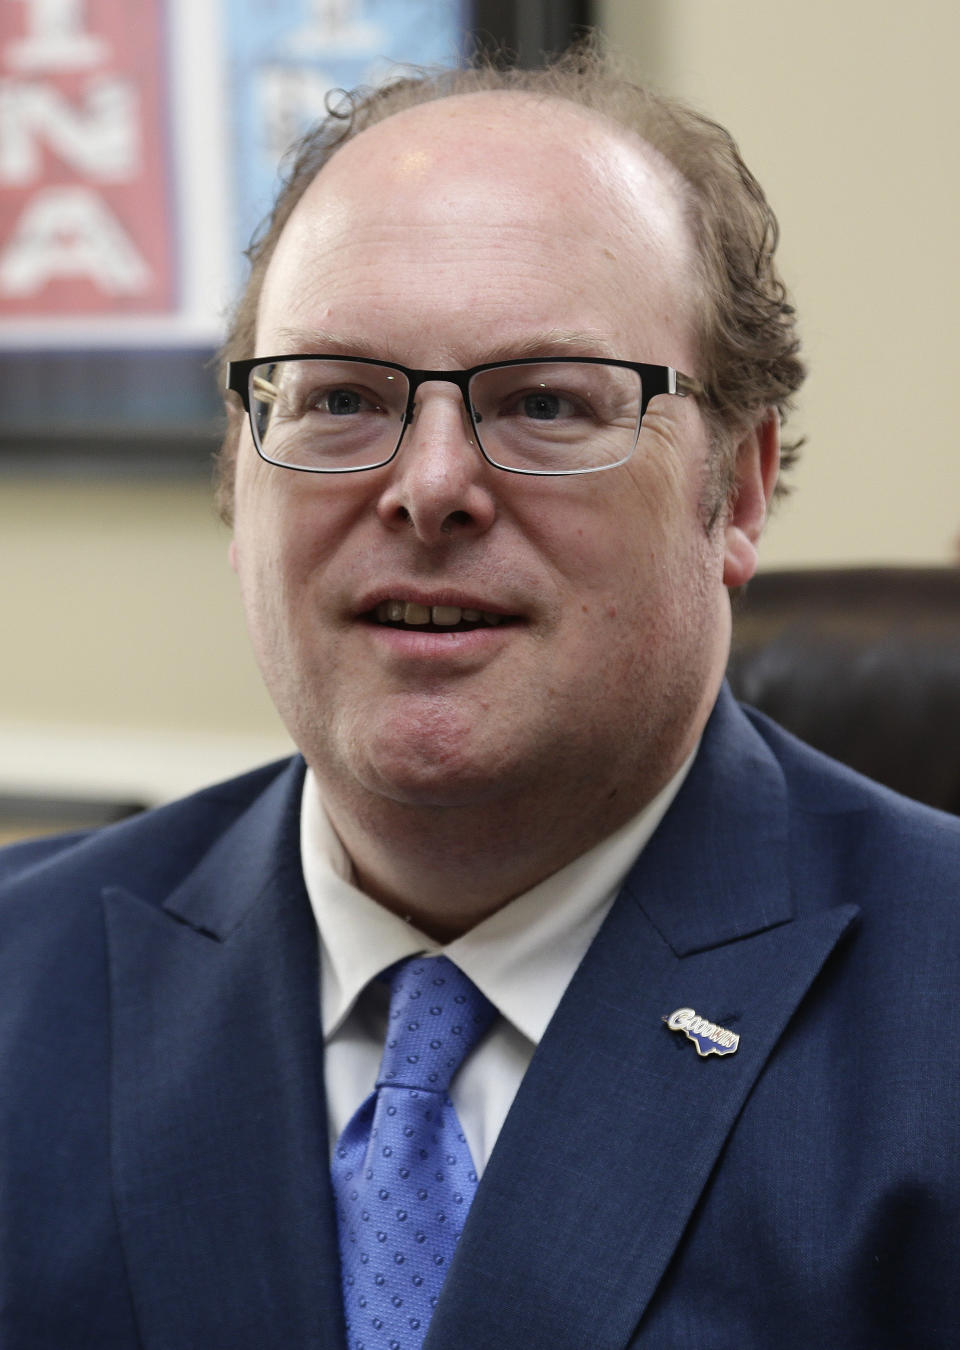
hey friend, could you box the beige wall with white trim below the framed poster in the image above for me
[0,478,289,802]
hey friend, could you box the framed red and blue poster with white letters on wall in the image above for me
[0,0,589,473]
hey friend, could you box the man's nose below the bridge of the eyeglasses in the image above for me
[377,382,497,545]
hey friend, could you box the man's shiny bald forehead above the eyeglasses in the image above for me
[259,92,697,369]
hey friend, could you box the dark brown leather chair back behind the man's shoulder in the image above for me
[728,567,960,815]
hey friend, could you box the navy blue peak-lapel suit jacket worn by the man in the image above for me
[0,693,960,1350]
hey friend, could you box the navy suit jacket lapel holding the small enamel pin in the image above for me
[424,697,856,1350]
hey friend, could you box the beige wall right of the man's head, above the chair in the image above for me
[599,0,960,566]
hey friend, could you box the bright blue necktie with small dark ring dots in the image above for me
[332,956,496,1350]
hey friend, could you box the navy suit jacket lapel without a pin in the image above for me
[104,772,343,1350]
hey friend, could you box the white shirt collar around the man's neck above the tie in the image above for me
[300,749,697,1045]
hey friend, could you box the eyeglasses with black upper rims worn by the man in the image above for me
[227,356,698,474]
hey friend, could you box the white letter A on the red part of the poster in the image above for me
[0,188,150,296]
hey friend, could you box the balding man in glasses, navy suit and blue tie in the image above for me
[0,47,960,1350]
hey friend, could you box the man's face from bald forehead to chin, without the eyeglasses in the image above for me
[234,95,756,829]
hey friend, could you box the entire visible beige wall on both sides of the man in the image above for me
[0,0,960,799]
